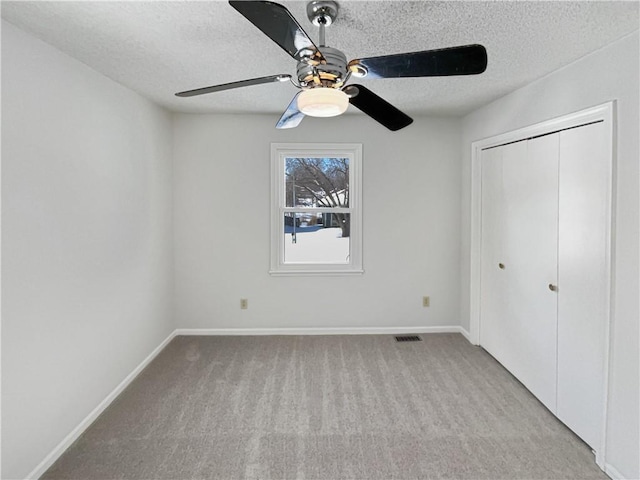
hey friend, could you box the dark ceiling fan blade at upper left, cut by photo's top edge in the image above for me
[229,0,326,65]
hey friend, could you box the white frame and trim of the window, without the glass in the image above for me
[269,143,364,276]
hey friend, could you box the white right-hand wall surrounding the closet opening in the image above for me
[460,32,640,479]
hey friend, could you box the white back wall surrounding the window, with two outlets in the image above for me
[174,112,460,328]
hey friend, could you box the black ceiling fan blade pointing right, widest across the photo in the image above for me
[349,45,487,78]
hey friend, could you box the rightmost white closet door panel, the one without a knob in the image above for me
[557,123,611,449]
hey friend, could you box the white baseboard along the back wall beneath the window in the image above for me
[174,326,468,336]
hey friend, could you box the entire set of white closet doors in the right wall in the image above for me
[479,108,612,461]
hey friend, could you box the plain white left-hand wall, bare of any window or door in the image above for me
[2,22,173,479]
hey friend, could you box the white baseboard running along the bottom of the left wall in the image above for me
[27,330,176,480]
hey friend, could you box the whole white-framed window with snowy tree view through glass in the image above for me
[270,143,362,275]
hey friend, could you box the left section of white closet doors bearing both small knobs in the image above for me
[480,134,559,411]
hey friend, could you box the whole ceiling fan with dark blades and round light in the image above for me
[176,0,487,131]
